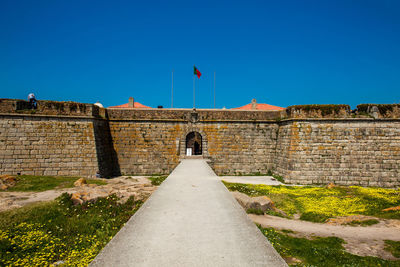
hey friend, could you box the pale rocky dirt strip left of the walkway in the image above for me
[0,176,157,212]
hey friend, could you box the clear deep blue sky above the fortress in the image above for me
[0,0,400,108]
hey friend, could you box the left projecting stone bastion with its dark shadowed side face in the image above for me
[0,99,114,180]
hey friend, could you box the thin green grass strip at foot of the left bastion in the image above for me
[1,175,107,192]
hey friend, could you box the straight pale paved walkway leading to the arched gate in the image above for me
[91,159,287,266]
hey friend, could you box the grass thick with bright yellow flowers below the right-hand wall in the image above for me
[224,182,400,225]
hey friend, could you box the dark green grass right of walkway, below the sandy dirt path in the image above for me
[259,227,400,267]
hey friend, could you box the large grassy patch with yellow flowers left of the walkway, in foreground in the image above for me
[0,193,142,266]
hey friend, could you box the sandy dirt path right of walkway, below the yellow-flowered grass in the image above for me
[248,214,400,260]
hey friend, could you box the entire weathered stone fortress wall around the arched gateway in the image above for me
[0,99,400,187]
